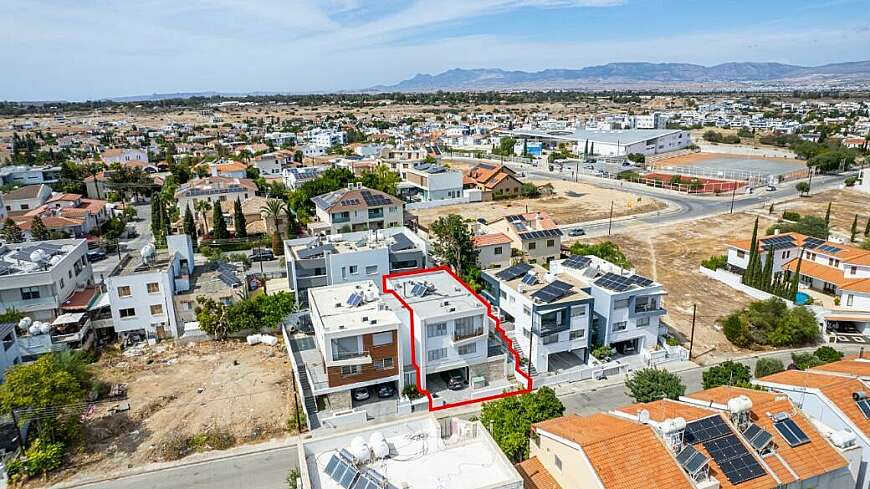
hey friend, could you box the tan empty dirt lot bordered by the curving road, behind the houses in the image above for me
[412,180,666,226]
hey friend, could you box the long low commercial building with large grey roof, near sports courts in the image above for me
[509,129,692,156]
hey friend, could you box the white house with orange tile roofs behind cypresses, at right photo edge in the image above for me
[728,233,870,334]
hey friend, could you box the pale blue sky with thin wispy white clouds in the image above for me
[0,0,870,100]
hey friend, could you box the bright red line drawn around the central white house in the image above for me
[382,266,532,411]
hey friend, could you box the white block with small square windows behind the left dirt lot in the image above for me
[106,234,194,339]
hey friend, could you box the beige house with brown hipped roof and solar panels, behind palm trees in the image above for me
[308,184,404,234]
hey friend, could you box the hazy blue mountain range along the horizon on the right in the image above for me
[366,61,870,92]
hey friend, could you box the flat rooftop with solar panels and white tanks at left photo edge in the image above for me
[0,239,85,277]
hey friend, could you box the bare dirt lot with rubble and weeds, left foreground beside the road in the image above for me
[44,341,293,482]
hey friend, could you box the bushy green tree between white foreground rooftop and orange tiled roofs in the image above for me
[480,387,565,462]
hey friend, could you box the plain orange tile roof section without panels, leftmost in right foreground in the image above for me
[534,413,694,489]
